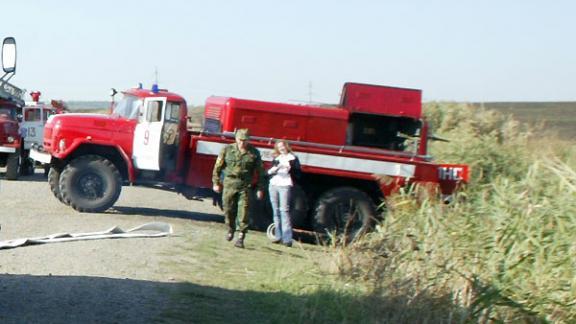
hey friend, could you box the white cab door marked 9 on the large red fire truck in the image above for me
[132,98,166,171]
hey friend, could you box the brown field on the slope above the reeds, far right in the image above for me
[475,102,576,140]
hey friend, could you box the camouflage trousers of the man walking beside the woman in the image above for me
[222,186,250,233]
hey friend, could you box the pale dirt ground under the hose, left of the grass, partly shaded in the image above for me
[0,170,230,323]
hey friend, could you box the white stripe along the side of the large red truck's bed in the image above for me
[196,141,416,178]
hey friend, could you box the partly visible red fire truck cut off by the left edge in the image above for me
[0,37,24,180]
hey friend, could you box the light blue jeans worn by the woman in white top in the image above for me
[268,186,292,243]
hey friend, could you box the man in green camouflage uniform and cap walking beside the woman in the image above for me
[212,129,266,248]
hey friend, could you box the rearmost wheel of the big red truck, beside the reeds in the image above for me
[314,187,376,244]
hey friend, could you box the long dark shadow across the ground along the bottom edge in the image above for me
[0,274,496,323]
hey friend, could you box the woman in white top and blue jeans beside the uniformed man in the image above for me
[268,140,301,247]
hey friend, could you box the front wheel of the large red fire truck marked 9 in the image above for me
[60,155,122,213]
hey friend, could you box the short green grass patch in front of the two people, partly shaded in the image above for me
[163,230,388,323]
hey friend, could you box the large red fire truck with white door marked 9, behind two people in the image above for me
[31,83,468,239]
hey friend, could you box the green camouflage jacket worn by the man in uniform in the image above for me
[212,143,266,190]
